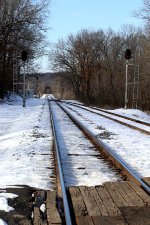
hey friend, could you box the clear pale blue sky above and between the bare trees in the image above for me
[40,0,143,71]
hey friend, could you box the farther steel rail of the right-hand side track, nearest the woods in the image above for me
[61,100,150,127]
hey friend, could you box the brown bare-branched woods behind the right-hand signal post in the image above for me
[49,1,150,110]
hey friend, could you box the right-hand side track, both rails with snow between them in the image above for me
[61,101,150,135]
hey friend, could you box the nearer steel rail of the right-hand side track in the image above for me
[61,100,150,135]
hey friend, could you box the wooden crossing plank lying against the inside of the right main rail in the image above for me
[128,182,150,206]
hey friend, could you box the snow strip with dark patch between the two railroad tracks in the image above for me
[61,105,150,177]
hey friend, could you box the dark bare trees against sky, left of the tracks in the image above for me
[0,0,48,98]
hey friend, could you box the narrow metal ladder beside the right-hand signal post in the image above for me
[132,65,139,109]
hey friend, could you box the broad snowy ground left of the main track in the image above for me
[0,96,53,224]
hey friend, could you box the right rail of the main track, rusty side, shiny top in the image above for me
[57,102,150,194]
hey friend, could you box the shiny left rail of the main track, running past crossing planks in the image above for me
[48,100,72,225]
